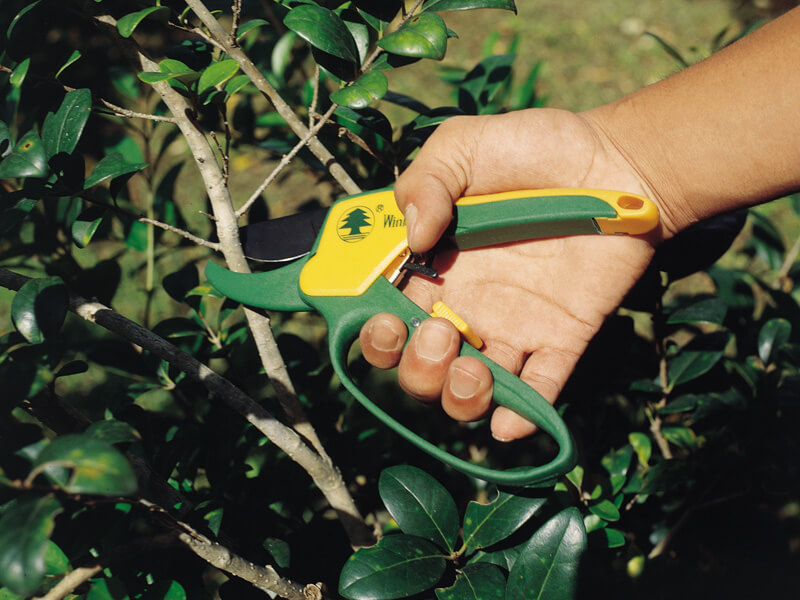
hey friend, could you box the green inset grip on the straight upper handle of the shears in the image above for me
[450,194,617,250]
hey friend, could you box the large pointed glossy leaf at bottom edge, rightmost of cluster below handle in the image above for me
[505,507,586,600]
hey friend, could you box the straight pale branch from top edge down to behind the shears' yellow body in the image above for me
[186,0,361,194]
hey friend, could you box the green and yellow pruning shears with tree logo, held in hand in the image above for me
[206,189,659,486]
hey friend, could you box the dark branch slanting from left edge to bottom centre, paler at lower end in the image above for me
[0,268,373,546]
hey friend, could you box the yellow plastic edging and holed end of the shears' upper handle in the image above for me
[456,188,658,235]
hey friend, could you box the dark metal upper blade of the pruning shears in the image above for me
[239,208,328,263]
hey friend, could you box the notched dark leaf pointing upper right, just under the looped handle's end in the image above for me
[463,492,547,552]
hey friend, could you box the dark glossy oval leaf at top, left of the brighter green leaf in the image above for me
[283,4,358,63]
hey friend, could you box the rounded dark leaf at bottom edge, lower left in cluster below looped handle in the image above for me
[339,534,446,600]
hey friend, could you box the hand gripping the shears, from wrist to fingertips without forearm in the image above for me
[360,109,654,440]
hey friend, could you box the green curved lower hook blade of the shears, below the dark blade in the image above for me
[206,259,312,311]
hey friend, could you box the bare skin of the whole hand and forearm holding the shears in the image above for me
[360,9,800,441]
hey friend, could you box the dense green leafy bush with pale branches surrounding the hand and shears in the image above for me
[0,0,800,600]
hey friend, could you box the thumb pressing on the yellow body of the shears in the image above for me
[395,117,474,252]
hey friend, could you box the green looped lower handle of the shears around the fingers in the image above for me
[304,277,577,486]
